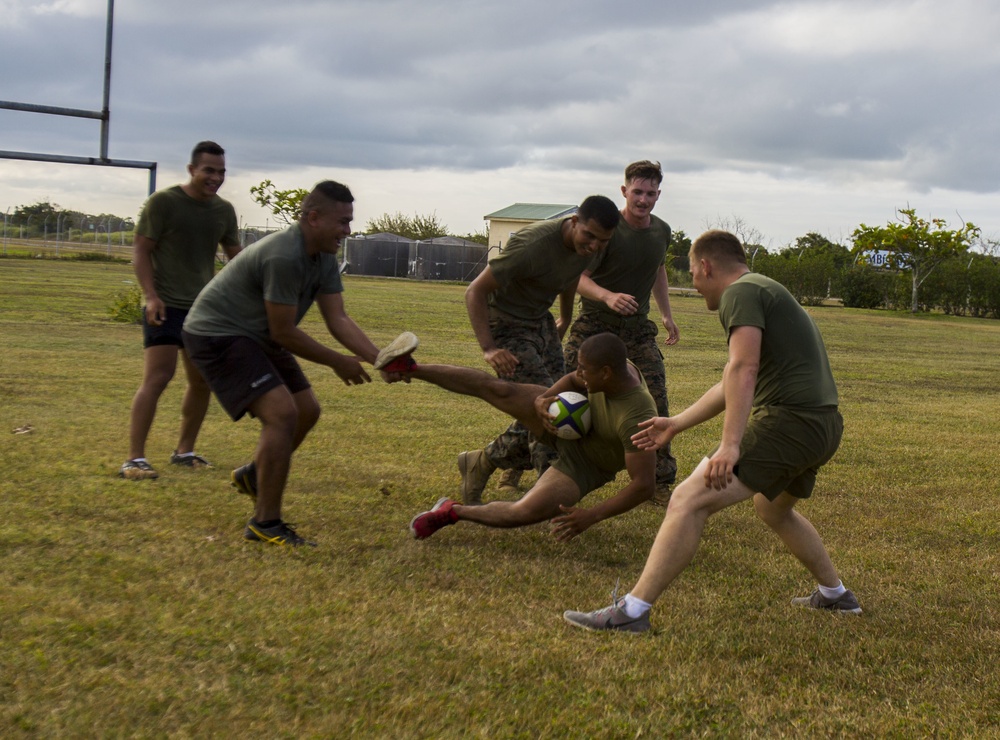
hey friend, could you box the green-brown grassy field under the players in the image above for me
[0,260,1000,738]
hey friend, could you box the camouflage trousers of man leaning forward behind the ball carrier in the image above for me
[486,314,565,475]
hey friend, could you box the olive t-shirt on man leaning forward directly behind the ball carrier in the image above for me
[488,219,594,321]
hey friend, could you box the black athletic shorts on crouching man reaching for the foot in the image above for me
[184,332,310,421]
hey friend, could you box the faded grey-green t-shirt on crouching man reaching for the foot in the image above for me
[184,224,344,344]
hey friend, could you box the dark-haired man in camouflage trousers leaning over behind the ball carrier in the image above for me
[458,195,620,504]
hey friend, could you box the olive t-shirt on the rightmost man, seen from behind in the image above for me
[719,272,837,408]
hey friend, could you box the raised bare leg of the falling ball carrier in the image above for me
[410,363,547,436]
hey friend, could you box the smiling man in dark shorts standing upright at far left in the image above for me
[118,141,240,480]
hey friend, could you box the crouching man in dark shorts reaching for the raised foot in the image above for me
[184,180,394,545]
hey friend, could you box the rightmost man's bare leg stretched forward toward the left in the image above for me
[630,458,753,604]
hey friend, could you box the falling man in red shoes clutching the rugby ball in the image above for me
[394,334,656,540]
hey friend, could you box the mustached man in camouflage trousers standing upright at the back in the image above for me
[565,160,680,506]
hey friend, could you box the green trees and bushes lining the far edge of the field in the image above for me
[5,186,1000,319]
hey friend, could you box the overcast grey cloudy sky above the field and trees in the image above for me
[0,0,1000,247]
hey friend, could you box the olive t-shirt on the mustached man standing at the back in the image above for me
[580,216,670,314]
